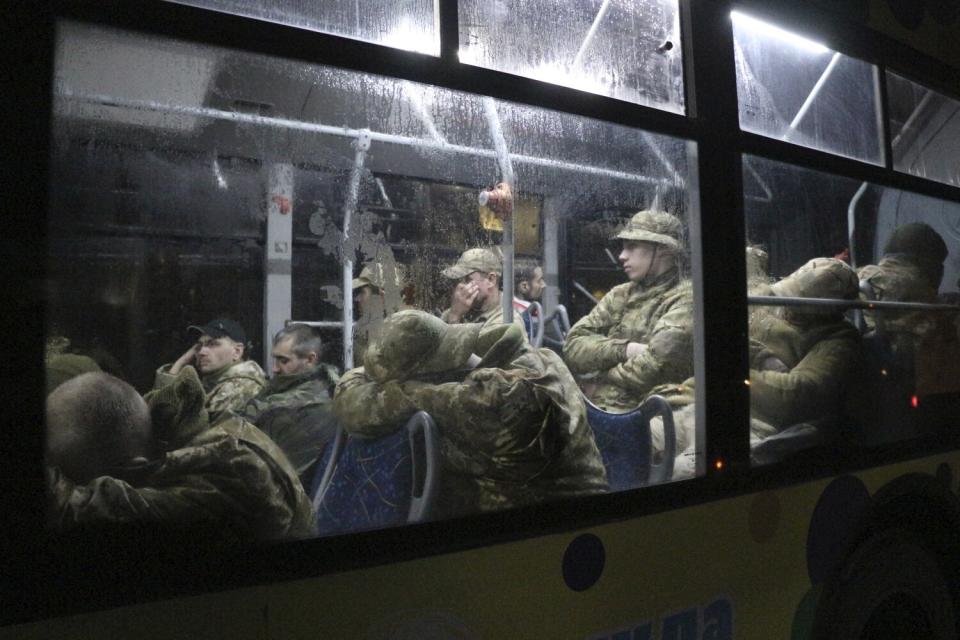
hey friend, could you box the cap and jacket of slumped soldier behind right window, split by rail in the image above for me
[750,258,860,438]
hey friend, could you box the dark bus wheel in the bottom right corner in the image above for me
[820,529,957,640]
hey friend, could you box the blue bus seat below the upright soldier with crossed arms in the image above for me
[584,396,677,491]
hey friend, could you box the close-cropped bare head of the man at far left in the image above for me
[47,372,152,483]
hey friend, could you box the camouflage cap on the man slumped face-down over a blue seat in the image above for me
[363,310,482,382]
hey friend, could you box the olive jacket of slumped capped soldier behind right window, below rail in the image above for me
[750,314,860,431]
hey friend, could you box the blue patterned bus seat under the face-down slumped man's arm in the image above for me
[314,411,440,535]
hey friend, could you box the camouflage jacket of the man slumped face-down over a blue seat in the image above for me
[334,332,607,517]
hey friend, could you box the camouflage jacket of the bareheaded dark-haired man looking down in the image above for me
[237,364,340,475]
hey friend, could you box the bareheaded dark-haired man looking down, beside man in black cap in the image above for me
[237,324,340,477]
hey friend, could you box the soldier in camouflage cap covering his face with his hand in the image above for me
[440,247,526,336]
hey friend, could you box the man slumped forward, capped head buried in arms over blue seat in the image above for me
[334,311,607,517]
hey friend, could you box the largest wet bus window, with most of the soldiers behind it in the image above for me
[47,18,702,538]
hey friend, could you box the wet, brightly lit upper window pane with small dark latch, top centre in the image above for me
[459,0,684,113]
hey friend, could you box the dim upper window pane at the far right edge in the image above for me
[887,71,960,186]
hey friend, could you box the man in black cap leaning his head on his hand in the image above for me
[153,318,267,420]
